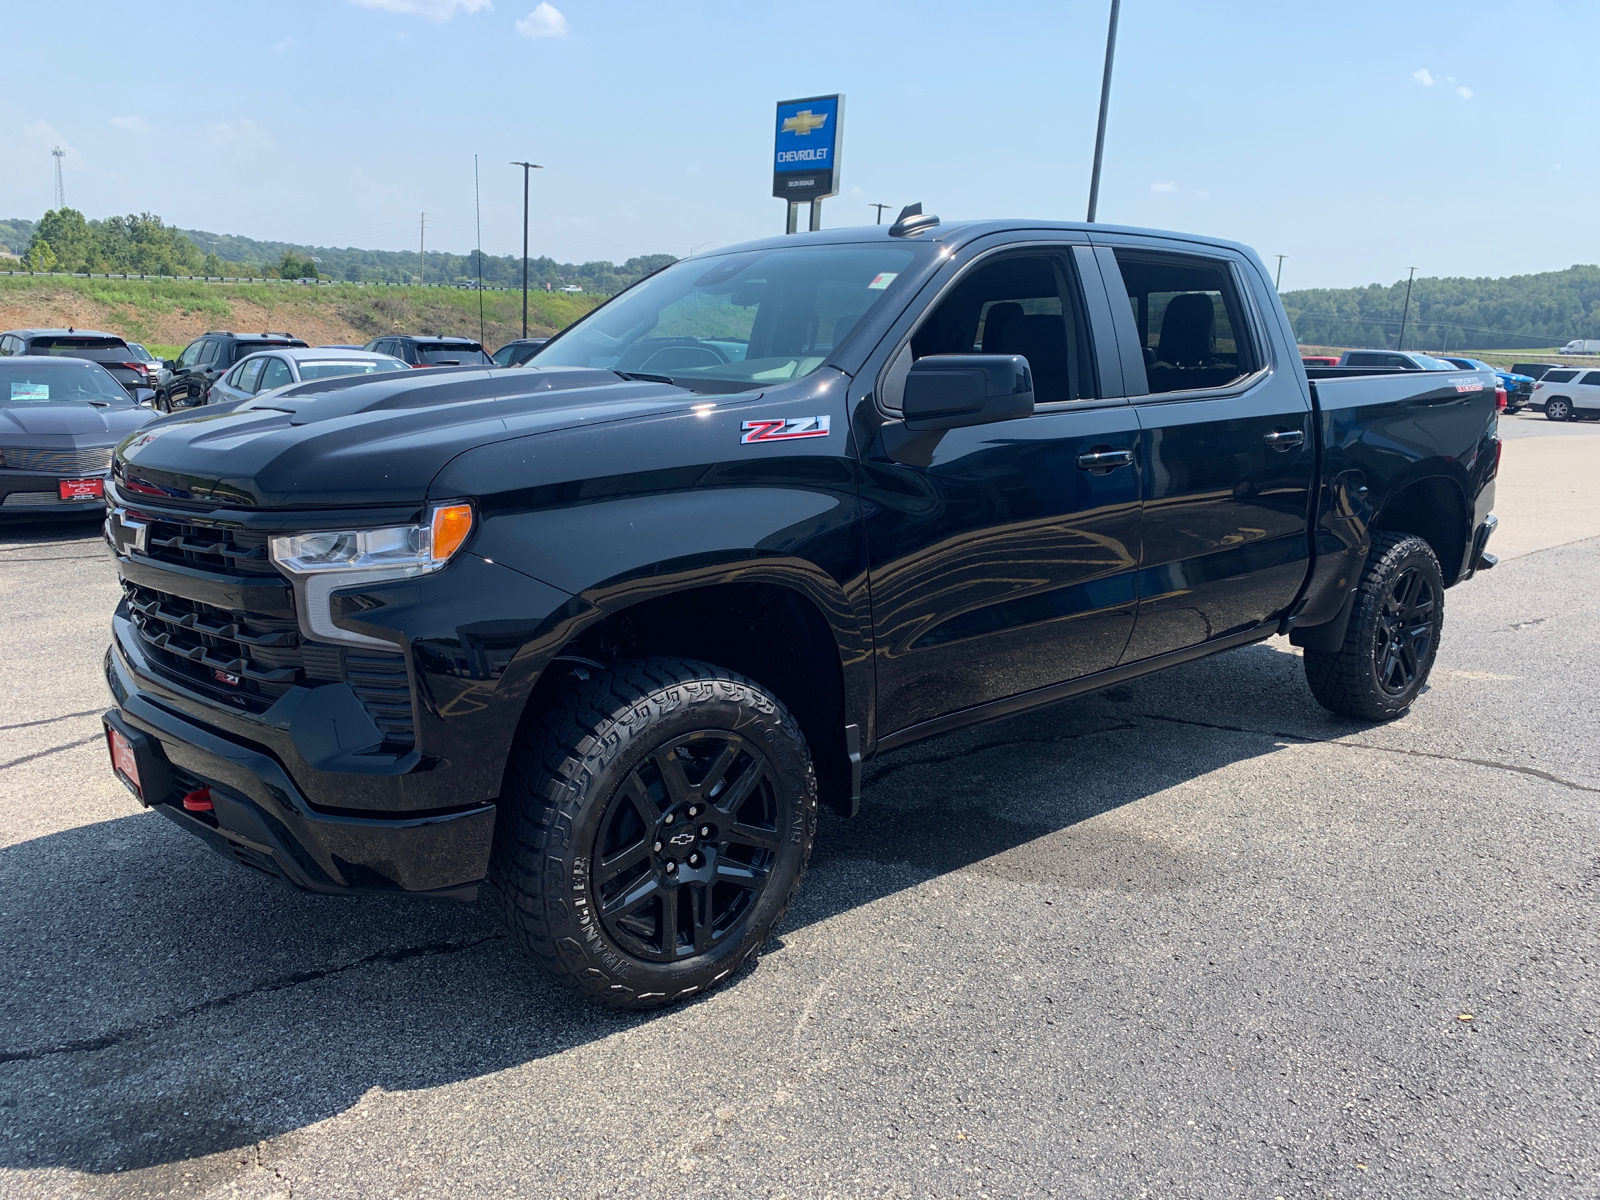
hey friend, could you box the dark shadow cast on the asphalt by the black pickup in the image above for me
[0,646,1355,1177]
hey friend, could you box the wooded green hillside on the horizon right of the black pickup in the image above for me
[1283,266,1600,352]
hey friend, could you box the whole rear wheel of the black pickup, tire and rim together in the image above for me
[1304,531,1445,722]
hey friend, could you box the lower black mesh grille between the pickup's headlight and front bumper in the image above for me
[122,579,416,750]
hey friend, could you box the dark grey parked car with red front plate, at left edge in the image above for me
[0,354,154,517]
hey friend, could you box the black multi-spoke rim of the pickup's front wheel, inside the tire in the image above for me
[590,730,782,962]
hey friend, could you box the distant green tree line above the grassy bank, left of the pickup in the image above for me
[0,208,677,294]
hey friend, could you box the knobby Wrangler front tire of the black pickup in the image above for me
[488,658,818,1010]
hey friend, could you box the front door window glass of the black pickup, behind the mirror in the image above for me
[908,254,1096,406]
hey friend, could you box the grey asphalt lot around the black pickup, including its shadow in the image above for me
[0,414,1600,1200]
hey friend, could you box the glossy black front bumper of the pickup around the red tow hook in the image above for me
[104,645,494,901]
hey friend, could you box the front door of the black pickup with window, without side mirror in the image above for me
[861,248,1139,738]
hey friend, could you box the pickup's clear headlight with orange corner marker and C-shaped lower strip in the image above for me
[272,504,472,650]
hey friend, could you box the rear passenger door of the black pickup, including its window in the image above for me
[1096,237,1312,662]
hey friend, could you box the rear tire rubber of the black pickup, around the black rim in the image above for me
[1306,533,1445,722]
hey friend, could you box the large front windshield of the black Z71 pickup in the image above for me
[530,245,915,392]
